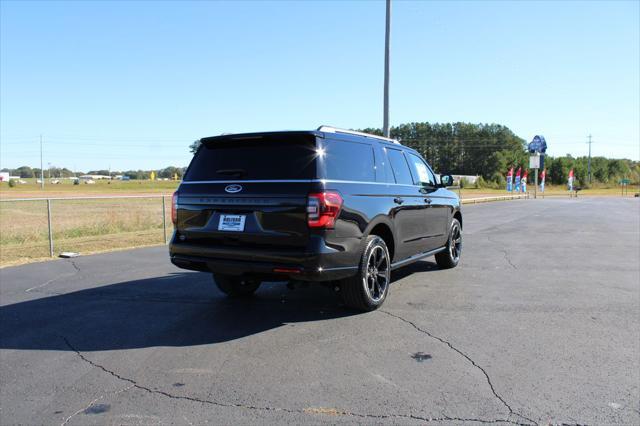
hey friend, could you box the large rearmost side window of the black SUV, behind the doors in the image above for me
[322,140,376,182]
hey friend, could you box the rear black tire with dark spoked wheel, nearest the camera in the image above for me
[340,235,391,311]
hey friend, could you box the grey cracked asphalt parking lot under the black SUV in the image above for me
[0,198,640,425]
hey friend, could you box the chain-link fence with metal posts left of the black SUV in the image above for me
[0,195,172,265]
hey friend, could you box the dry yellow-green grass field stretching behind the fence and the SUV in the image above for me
[0,179,637,267]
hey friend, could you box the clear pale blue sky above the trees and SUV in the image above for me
[0,1,640,171]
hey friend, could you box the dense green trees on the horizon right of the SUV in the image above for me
[361,123,640,186]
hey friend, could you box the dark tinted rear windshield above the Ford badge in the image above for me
[184,136,317,181]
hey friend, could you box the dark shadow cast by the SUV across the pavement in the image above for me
[0,262,437,351]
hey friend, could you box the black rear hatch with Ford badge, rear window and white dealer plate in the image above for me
[176,132,317,249]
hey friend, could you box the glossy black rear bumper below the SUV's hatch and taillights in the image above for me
[169,237,361,281]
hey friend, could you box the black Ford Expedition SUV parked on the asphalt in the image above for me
[170,126,462,310]
